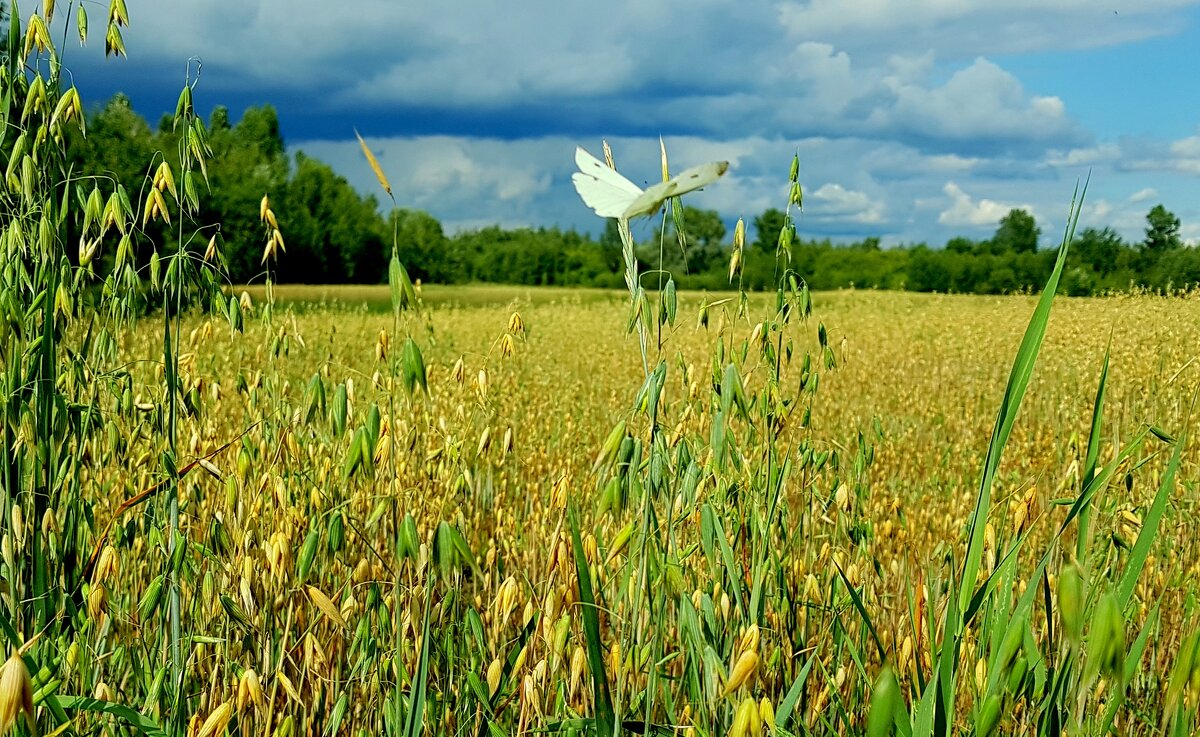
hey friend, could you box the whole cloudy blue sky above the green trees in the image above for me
[66,0,1200,246]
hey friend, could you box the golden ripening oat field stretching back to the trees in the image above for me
[46,287,1200,736]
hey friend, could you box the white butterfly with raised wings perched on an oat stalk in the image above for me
[571,146,730,220]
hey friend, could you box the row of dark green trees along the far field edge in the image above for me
[68,95,1200,294]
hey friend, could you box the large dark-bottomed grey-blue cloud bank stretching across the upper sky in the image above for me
[98,0,1094,146]
